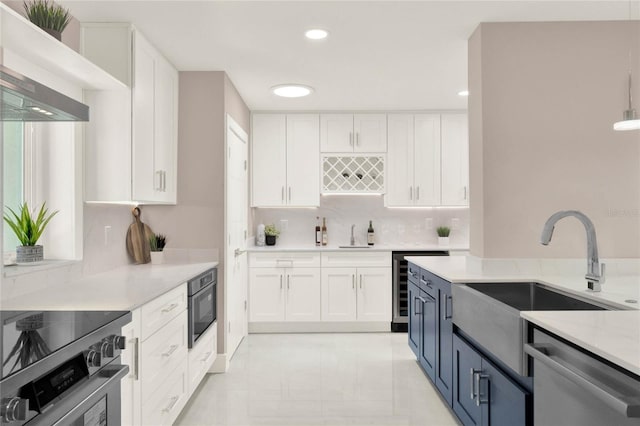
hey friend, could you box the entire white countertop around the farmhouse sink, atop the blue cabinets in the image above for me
[407,256,640,375]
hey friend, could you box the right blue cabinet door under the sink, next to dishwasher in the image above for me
[480,360,531,426]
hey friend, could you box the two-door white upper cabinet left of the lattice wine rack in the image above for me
[251,114,320,207]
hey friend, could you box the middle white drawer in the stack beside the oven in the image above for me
[140,310,188,402]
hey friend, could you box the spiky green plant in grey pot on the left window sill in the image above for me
[3,203,58,263]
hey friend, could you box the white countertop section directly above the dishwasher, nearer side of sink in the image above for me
[520,311,640,375]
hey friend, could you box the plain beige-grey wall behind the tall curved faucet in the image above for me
[469,21,640,258]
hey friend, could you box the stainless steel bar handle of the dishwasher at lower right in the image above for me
[524,343,640,418]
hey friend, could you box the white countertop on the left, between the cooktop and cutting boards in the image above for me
[0,262,218,311]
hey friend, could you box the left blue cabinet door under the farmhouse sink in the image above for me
[453,335,482,426]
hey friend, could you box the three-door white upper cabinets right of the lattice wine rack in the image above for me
[385,113,469,207]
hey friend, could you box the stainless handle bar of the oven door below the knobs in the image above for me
[48,365,129,426]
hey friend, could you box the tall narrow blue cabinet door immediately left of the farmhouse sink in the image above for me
[436,280,453,406]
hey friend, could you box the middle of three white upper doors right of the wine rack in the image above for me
[413,114,440,206]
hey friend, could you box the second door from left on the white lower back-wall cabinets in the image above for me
[285,268,320,321]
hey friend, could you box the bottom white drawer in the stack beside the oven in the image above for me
[142,363,189,426]
